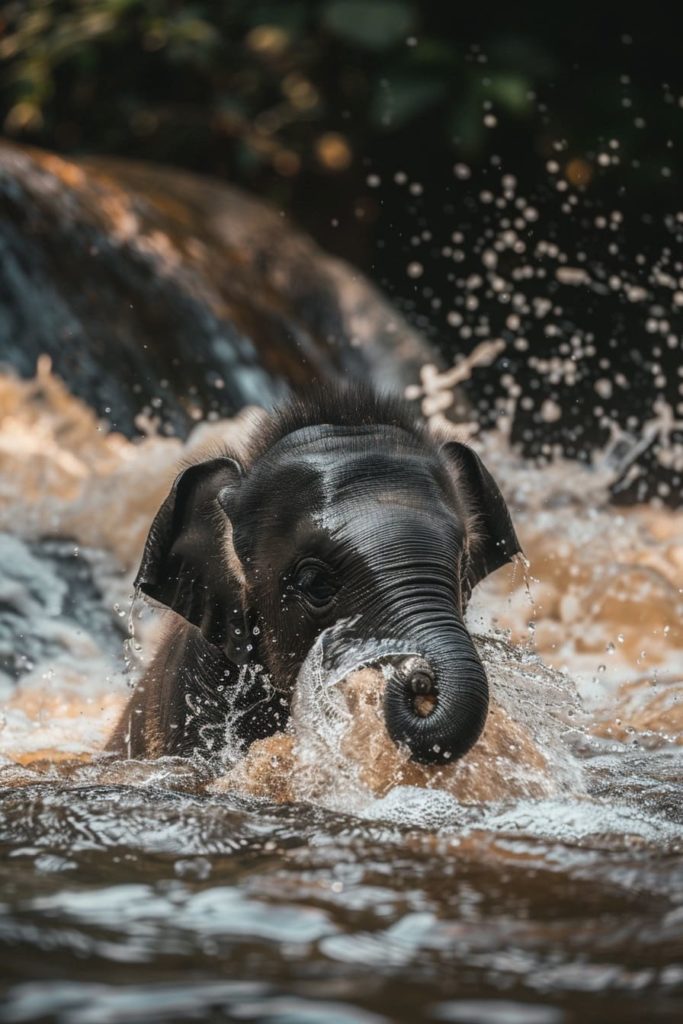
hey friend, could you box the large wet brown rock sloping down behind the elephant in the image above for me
[0,142,438,436]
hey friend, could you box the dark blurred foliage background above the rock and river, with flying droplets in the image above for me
[0,0,683,503]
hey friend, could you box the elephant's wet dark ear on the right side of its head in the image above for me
[441,441,522,596]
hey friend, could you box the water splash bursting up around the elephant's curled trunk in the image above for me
[220,622,586,820]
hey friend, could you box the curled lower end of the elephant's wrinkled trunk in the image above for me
[384,605,488,764]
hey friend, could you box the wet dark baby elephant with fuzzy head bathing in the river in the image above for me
[110,389,520,763]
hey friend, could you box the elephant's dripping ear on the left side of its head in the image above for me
[135,458,246,664]
